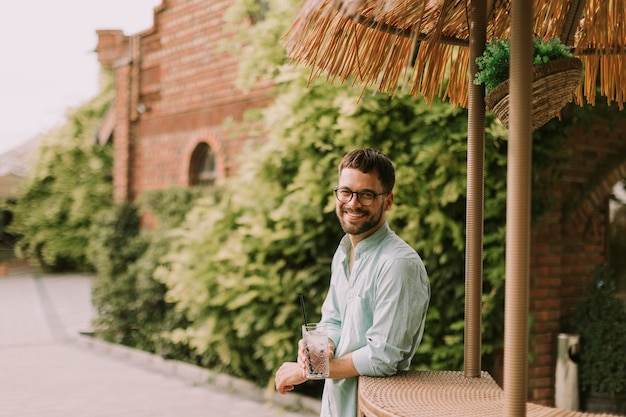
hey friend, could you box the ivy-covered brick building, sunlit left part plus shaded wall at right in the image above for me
[97,0,626,405]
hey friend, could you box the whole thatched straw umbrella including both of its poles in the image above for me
[286,0,626,416]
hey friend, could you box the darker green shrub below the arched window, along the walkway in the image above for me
[90,187,199,354]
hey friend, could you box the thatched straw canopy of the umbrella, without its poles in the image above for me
[287,0,626,108]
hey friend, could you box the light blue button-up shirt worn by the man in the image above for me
[321,222,430,417]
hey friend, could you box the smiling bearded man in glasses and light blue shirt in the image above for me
[276,148,430,417]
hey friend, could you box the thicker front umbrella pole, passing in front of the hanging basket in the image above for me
[504,0,533,417]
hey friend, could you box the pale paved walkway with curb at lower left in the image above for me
[0,274,318,417]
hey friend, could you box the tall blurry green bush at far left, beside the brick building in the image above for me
[9,86,113,271]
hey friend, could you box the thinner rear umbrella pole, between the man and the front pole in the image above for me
[464,0,487,378]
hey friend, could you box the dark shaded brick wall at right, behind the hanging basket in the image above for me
[528,107,626,405]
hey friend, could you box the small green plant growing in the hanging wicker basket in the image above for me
[474,38,573,93]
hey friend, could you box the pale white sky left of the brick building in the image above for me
[0,0,161,155]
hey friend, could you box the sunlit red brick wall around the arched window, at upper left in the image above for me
[97,0,271,201]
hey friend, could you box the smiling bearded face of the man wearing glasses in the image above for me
[335,168,393,243]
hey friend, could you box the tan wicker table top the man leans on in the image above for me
[359,371,607,417]
